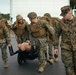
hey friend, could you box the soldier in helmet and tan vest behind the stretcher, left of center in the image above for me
[12,15,28,44]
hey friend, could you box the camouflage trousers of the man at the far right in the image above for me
[61,49,76,75]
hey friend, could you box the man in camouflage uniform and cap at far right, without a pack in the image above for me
[55,6,76,75]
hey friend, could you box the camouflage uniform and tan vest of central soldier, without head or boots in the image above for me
[29,20,55,64]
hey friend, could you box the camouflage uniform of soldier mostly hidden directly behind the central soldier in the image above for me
[40,16,53,59]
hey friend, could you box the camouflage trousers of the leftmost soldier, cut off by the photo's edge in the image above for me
[0,43,8,61]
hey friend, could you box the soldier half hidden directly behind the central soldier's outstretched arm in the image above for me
[39,16,54,64]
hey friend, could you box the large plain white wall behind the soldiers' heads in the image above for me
[10,0,70,22]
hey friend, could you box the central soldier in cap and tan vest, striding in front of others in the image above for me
[28,12,55,72]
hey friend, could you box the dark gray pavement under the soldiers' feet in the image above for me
[0,34,66,75]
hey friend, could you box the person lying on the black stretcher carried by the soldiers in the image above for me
[9,41,39,58]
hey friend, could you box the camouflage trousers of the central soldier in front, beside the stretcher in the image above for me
[39,38,47,64]
